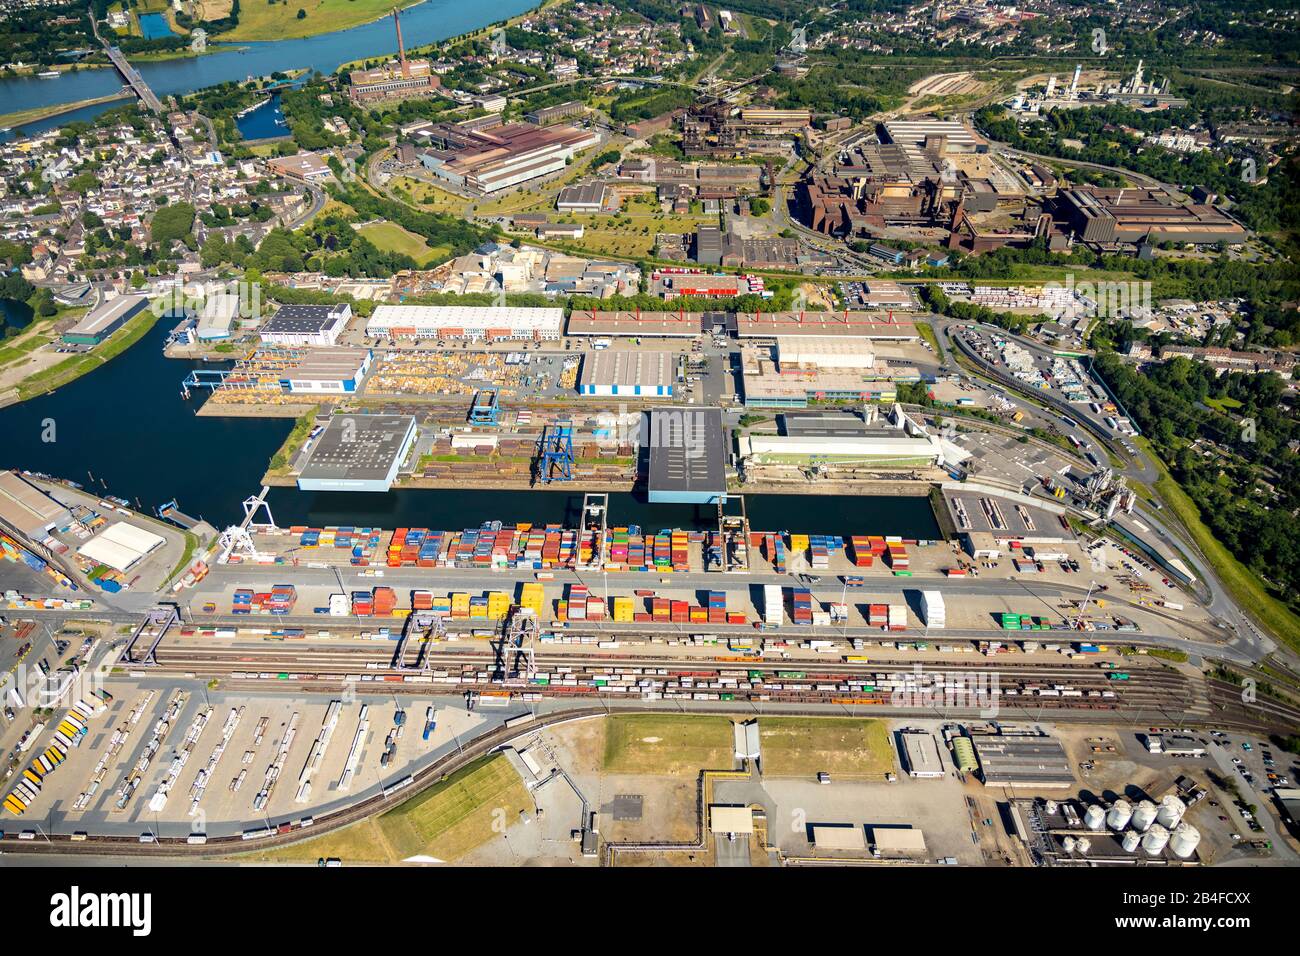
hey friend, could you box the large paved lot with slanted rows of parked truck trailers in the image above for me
[5,679,486,836]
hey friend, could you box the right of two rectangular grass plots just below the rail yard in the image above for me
[758,717,894,778]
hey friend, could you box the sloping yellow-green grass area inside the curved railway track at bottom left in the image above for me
[245,754,533,864]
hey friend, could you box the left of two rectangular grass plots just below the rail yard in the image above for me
[603,714,736,774]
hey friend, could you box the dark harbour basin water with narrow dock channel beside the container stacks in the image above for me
[0,319,939,538]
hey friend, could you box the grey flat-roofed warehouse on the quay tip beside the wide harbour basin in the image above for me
[298,415,416,492]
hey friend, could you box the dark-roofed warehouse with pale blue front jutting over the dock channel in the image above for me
[646,408,727,505]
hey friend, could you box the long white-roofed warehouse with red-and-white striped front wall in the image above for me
[365,306,564,342]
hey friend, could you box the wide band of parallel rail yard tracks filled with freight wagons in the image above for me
[129,643,1192,717]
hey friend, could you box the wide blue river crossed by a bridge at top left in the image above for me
[0,0,537,133]
